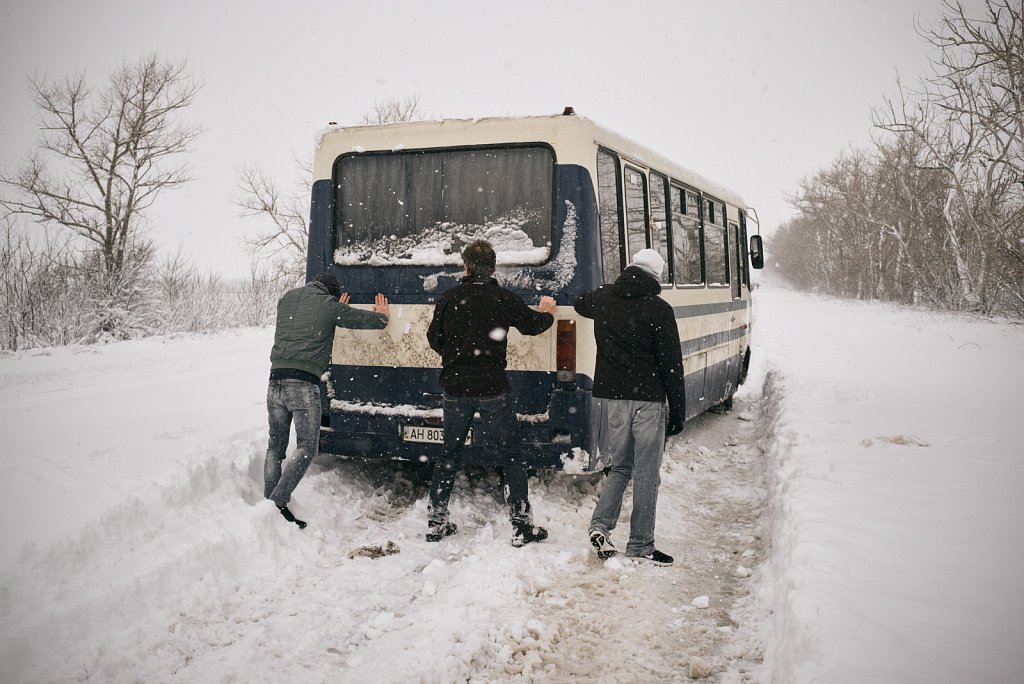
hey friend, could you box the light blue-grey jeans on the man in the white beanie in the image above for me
[590,399,665,556]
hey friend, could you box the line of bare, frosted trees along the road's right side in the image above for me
[771,0,1024,316]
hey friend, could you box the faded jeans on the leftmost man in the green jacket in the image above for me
[263,378,321,508]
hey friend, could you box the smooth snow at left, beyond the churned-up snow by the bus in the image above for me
[0,329,273,568]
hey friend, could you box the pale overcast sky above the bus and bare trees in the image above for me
[0,0,958,275]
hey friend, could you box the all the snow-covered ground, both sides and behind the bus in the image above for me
[0,278,1024,684]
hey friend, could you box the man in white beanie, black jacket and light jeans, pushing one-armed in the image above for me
[573,249,685,565]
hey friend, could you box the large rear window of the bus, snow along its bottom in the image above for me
[334,146,554,266]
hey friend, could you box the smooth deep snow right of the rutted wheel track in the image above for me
[755,280,1024,684]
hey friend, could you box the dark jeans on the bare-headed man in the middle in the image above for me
[427,394,534,524]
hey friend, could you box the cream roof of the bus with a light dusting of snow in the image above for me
[313,114,748,210]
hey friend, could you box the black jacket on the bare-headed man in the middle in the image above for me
[427,275,555,396]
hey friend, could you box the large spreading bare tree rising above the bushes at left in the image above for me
[0,55,201,273]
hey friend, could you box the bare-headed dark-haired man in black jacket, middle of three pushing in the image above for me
[426,240,555,546]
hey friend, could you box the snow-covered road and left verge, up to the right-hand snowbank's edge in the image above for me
[0,331,765,682]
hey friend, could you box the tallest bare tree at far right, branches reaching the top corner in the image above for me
[876,0,1024,310]
